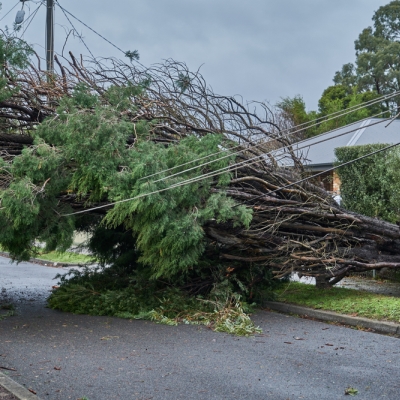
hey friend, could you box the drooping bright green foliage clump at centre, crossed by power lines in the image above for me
[105,135,252,278]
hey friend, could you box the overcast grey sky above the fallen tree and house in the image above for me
[0,0,389,110]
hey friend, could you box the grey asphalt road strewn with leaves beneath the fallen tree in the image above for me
[0,258,400,400]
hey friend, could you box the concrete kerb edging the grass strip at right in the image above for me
[264,301,400,335]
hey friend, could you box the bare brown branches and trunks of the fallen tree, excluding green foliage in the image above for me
[0,53,400,285]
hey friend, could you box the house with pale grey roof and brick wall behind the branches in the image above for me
[293,118,400,194]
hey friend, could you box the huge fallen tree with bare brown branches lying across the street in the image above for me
[0,33,400,298]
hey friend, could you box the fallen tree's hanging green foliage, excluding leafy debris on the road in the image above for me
[0,76,252,286]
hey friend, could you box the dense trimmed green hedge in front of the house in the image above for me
[335,144,400,222]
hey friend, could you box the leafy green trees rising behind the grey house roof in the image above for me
[277,0,400,137]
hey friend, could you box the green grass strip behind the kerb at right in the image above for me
[276,282,400,322]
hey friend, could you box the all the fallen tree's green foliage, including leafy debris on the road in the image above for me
[0,55,273,334]
